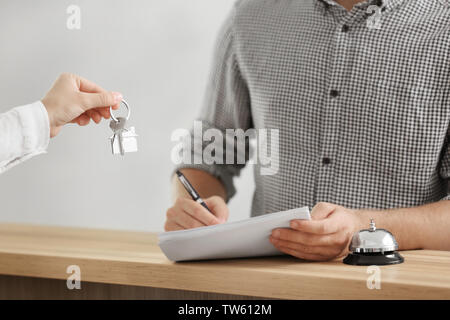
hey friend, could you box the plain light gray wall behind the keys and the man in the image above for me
[0,0,253,231]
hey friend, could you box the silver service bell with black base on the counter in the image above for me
[344,219,404,266]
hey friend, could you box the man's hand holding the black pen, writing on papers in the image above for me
[164,196,228,231]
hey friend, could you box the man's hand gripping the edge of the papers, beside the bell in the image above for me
[270,202,361,261]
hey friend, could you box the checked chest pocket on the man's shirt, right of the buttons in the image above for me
[357,81,448,177]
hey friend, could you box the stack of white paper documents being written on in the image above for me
[158,207,311,261]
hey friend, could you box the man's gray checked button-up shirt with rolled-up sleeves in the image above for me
[180,0,450,215]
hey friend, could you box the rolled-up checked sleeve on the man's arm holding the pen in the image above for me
[177,4,252,199]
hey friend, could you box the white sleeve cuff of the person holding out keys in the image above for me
[0,101,50,174]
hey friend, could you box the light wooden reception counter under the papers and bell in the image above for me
[0,224,450,299]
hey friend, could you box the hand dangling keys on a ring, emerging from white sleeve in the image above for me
[42,73,122,137]
